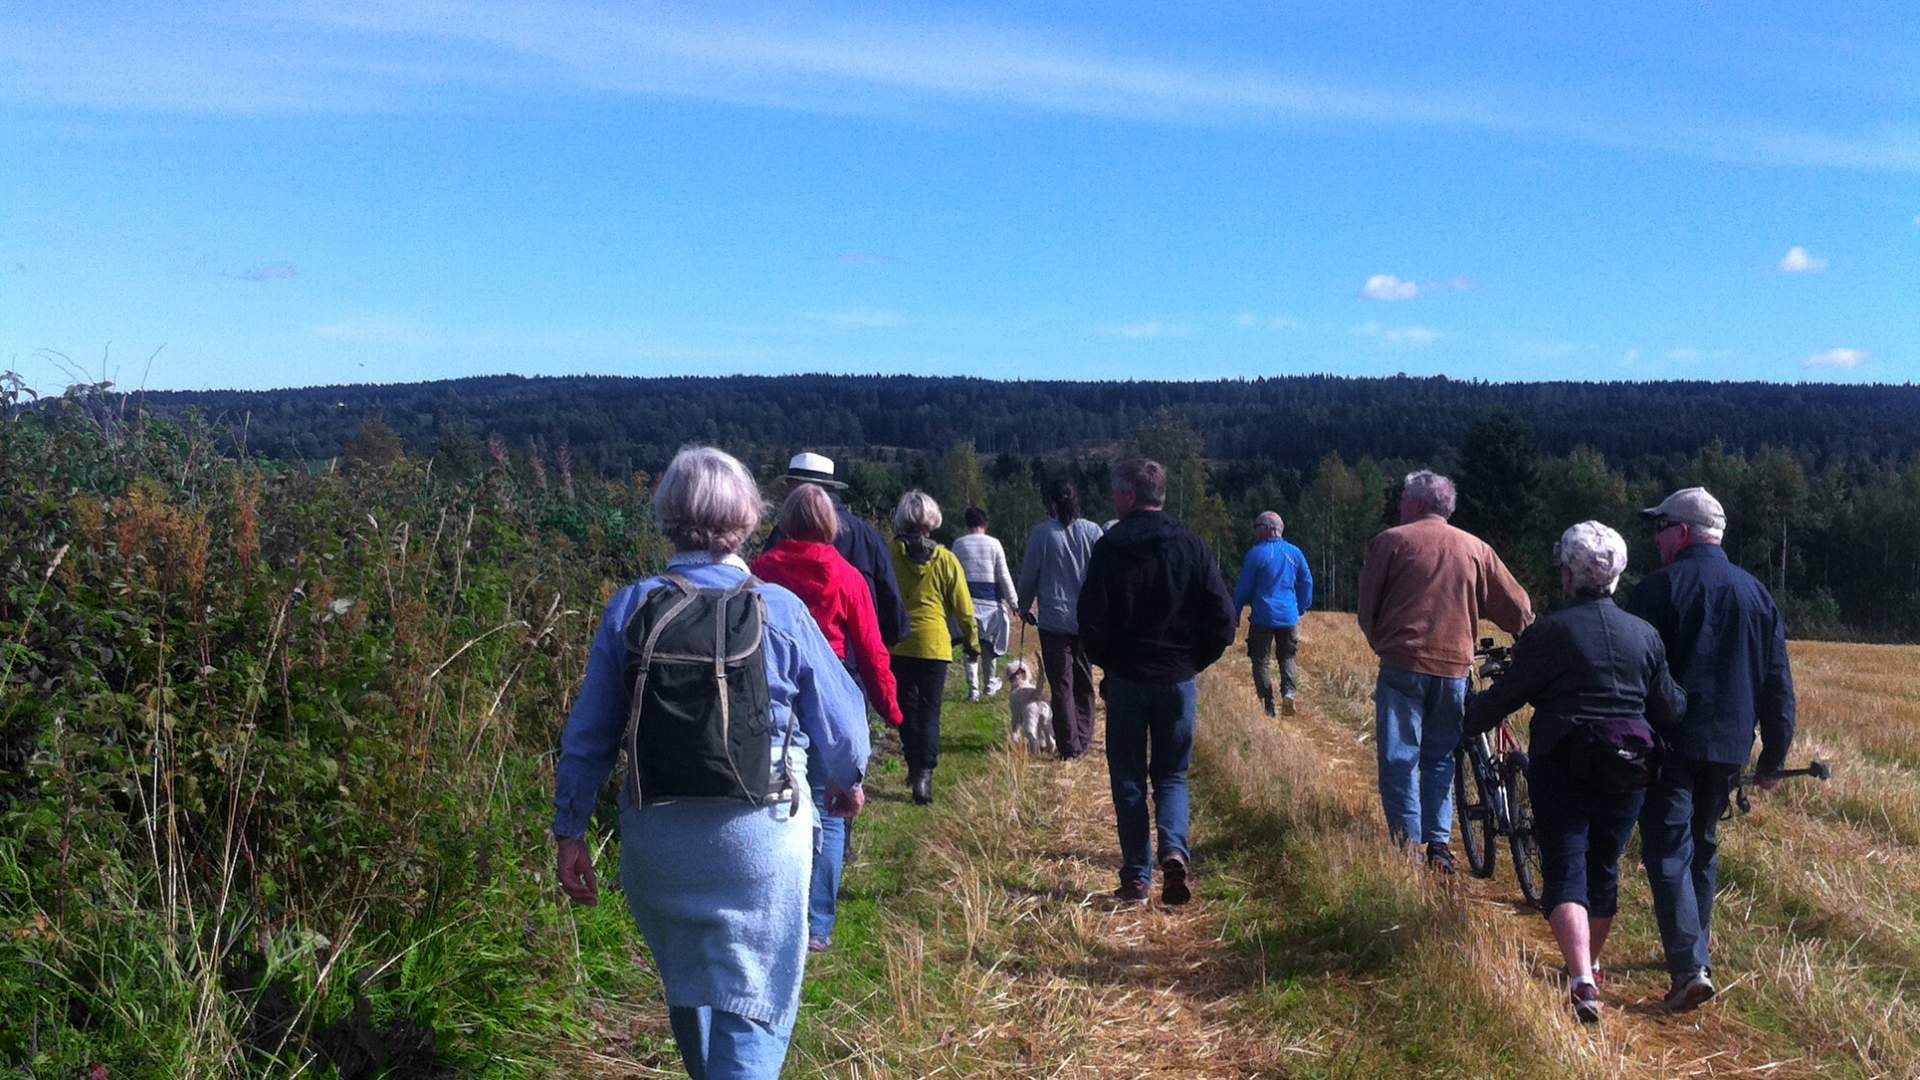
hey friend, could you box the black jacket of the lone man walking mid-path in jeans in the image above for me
[1079,509,1235,684]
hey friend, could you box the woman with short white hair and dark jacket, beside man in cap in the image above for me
[1467,521,1686,1022]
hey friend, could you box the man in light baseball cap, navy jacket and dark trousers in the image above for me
[1626,488,1793,1011]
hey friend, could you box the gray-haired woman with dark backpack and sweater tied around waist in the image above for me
[553,448,868,1076]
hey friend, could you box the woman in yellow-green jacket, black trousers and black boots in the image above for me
[887,490,979,805]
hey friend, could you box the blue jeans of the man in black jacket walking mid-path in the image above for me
[1100,675,1194,884]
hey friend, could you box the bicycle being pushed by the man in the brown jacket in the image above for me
[1453,638,1544,907]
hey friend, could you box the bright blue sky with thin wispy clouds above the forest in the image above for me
[0,0,1920,390]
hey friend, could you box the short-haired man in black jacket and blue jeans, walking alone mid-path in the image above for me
[1077,459,1235,903]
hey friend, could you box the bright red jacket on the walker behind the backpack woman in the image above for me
[749,540,900,726]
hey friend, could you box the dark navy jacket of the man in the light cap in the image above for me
[1626,544,1793,773]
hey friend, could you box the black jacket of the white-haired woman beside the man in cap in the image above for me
[1467,596,1686,761]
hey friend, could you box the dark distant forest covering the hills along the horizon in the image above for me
[45,375,1920,640]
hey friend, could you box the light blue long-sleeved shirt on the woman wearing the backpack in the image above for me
[553,553,870,836]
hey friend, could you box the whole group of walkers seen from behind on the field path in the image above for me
[553,448,1793,1078]
